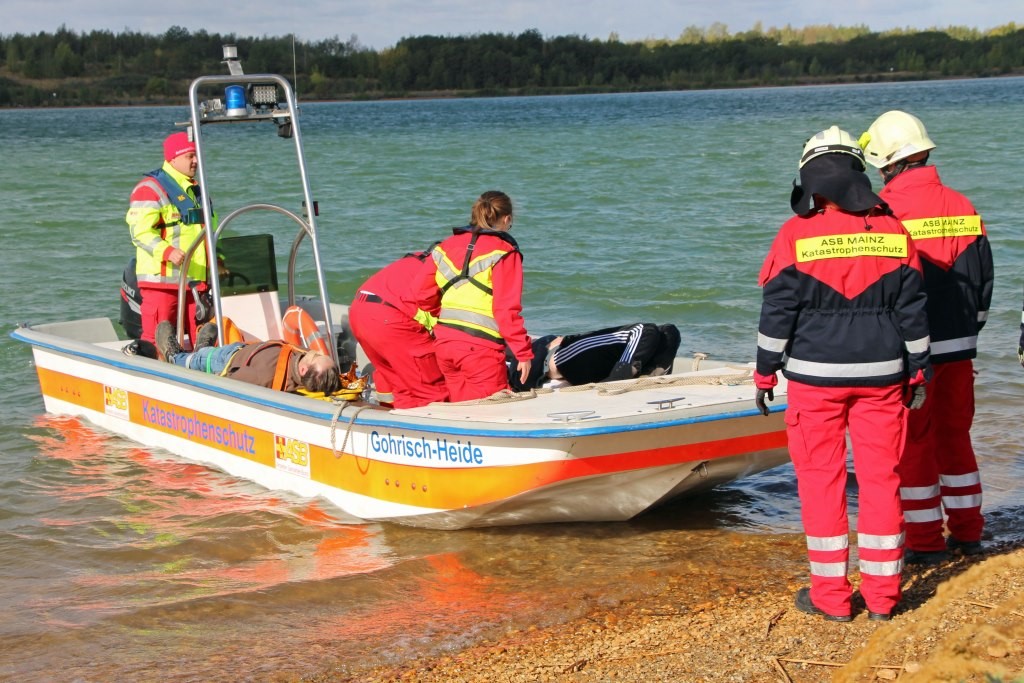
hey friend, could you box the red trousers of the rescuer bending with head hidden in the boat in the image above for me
[348,299,449,408]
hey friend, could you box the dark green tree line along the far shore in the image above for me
[0,24,1024,106]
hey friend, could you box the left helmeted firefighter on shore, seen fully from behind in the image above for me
[754,126,931,622]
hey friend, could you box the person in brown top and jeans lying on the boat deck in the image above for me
[157,321,341,394]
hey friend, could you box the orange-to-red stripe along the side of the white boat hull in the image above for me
[32,368,786,510]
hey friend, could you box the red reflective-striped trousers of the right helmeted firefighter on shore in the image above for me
[899,360,985,551]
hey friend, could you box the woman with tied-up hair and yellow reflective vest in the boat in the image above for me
[420,190,534,401]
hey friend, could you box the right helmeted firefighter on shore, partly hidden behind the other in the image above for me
[860,111,993,564]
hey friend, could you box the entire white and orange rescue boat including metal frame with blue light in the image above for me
[11,48,787,529]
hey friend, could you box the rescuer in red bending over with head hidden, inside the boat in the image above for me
[348,245,449,408]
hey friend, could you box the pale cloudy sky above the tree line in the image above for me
[0,0,1024,50]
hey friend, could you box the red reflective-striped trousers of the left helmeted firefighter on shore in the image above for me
[785,380,907,615]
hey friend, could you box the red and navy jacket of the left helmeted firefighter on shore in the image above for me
[757,209,931,387]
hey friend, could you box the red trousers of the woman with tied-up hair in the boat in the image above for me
[434,335,509,401]
